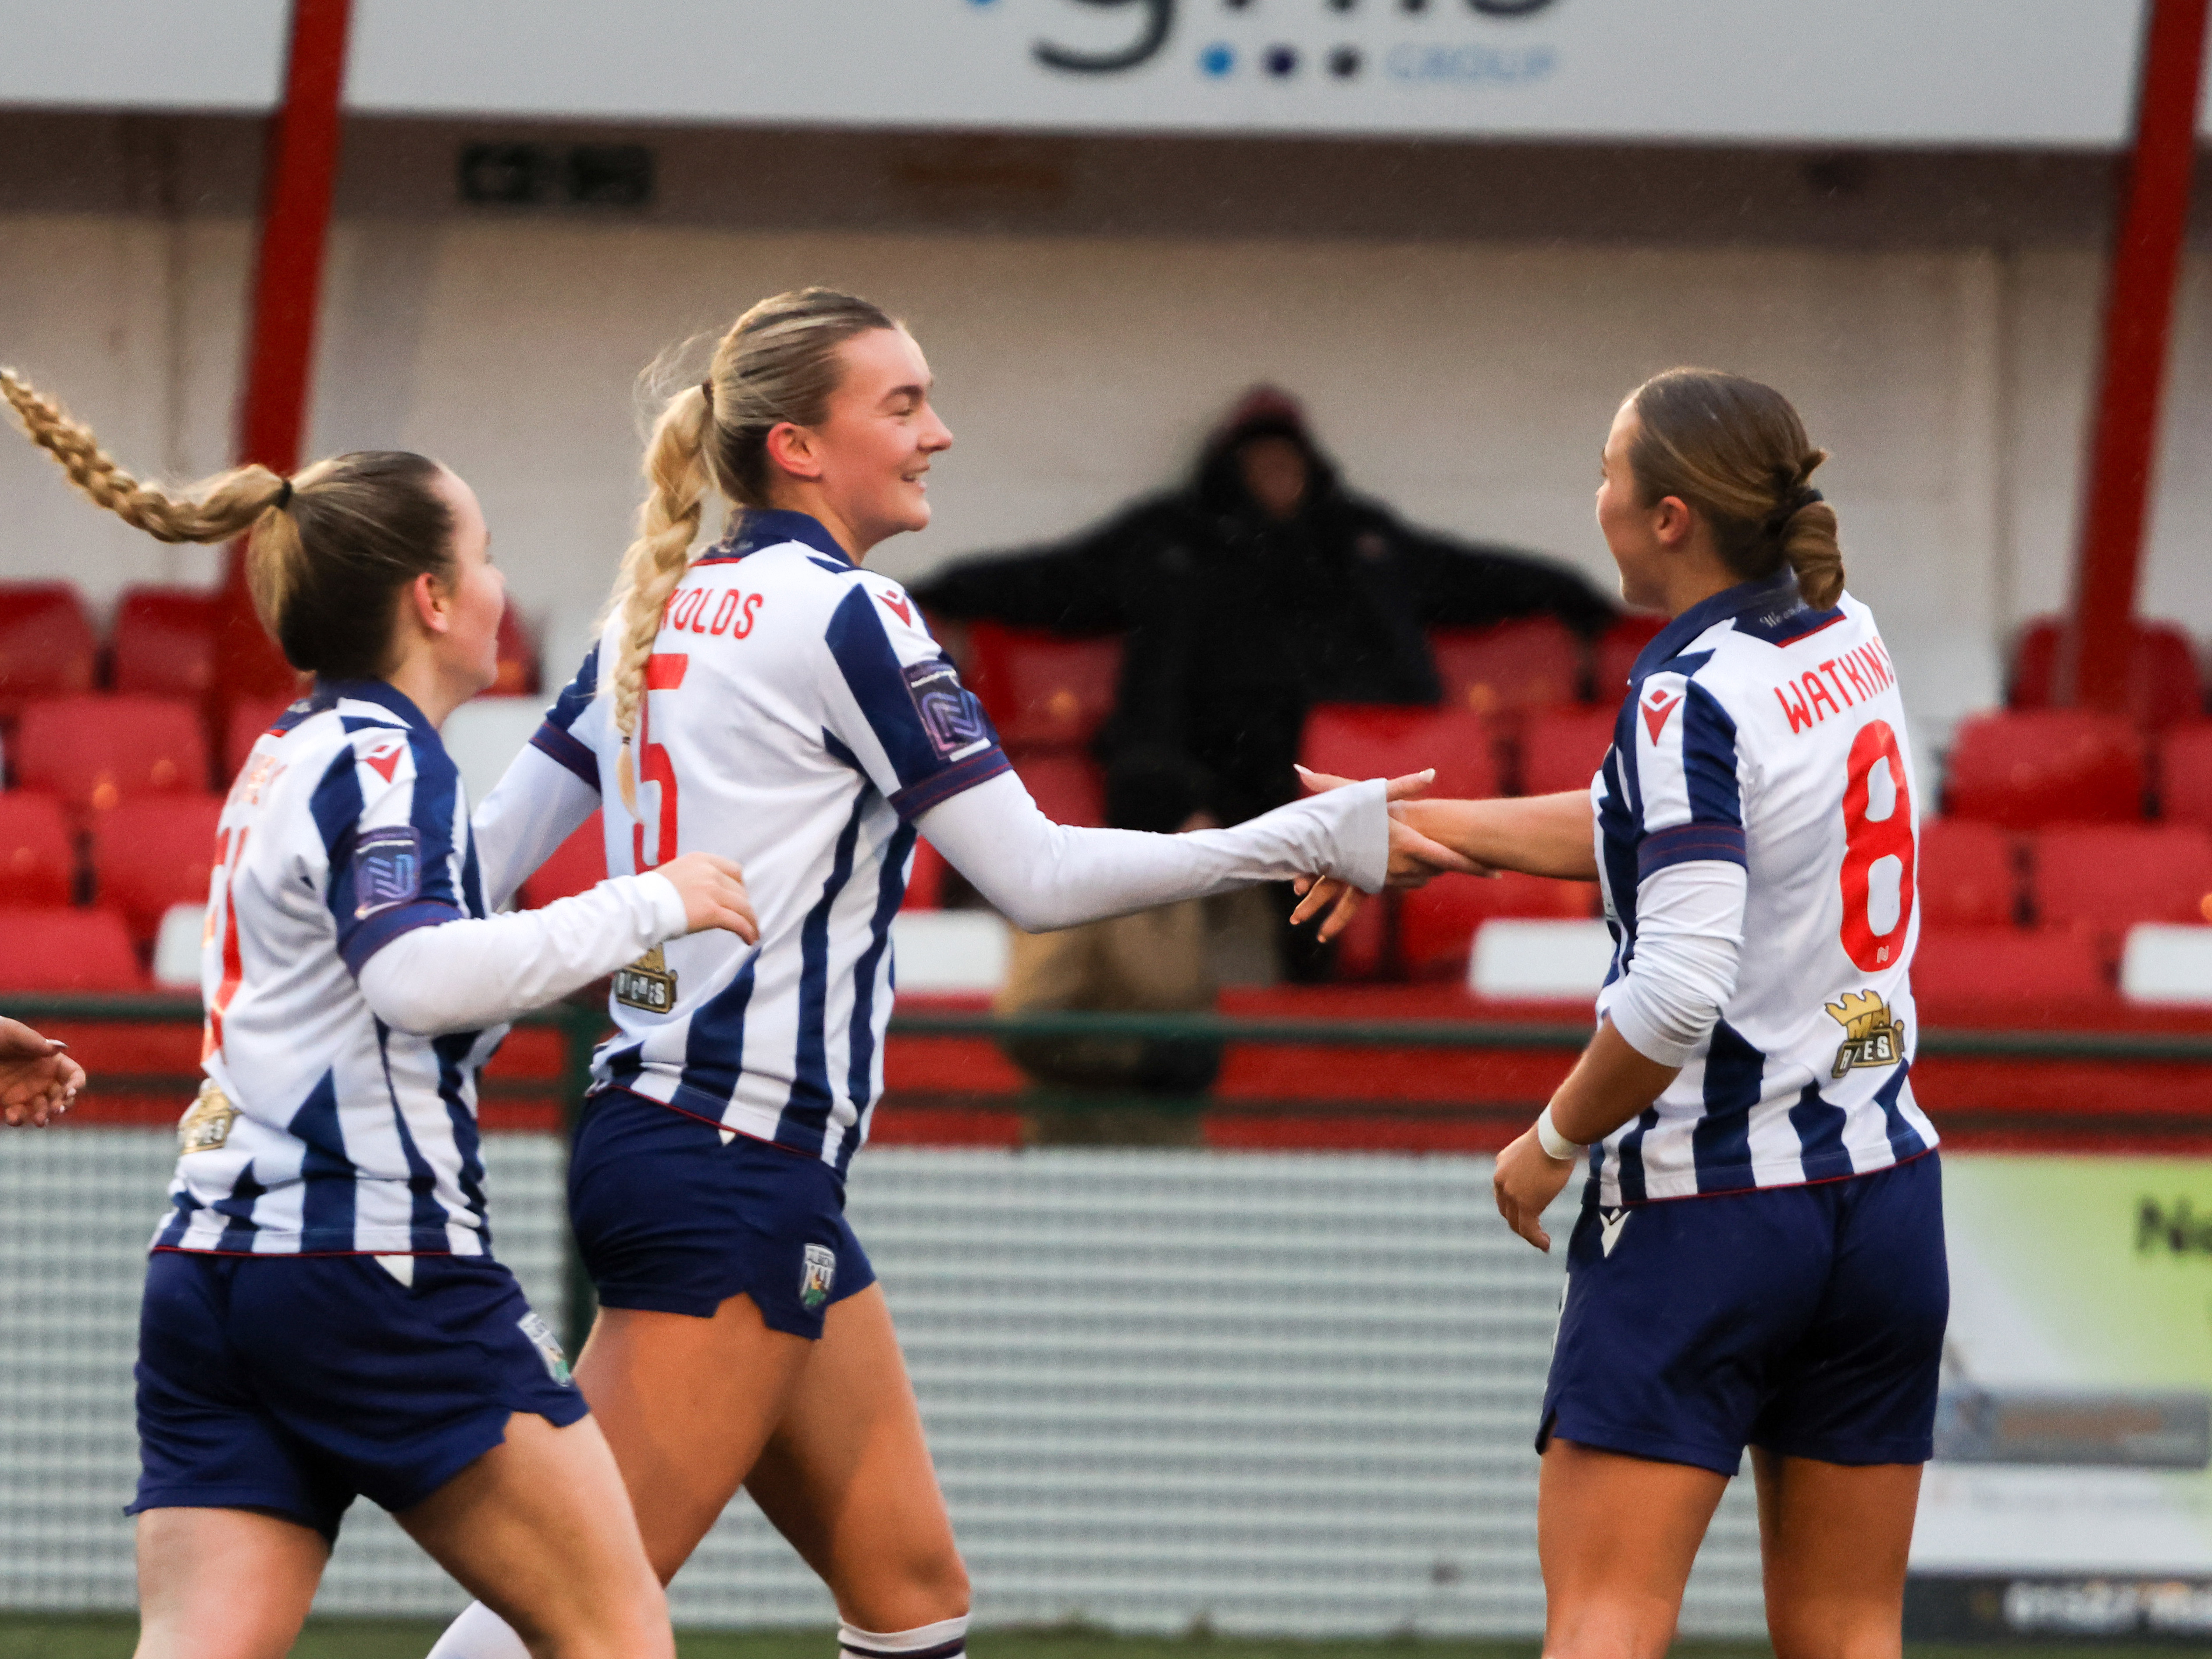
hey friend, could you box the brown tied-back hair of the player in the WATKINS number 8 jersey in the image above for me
[1628,370,1842,611]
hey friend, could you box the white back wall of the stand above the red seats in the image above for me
[0,217,2212,721]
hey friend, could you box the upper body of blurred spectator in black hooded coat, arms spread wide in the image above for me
[916,387,1615,823]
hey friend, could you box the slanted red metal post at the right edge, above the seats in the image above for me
[2057,0,2212,715]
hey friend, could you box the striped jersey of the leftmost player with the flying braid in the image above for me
[155,681,504,1257]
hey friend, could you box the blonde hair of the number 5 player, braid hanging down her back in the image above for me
[606,288,898,812]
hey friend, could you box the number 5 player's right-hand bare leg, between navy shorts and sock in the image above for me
[745,1285,969,1630]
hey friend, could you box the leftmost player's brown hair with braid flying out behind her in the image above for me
[0,370,453,679]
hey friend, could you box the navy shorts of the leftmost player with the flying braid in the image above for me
[128,1250,584,1540]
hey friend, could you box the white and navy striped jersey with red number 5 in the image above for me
[533,511,1009,1172]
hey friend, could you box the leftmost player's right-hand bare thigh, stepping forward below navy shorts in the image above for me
[398,1413,675,1659]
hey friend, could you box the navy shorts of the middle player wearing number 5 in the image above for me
[569,1088,876,1340]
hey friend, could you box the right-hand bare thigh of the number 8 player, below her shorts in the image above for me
[1752,1449,1920,1659]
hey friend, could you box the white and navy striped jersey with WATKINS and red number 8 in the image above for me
[1590,573,1935,1206]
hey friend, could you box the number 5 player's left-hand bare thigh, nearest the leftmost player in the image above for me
[575,1296,814,1584]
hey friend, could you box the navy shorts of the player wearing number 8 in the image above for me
[1535,1153,1951,1475]
